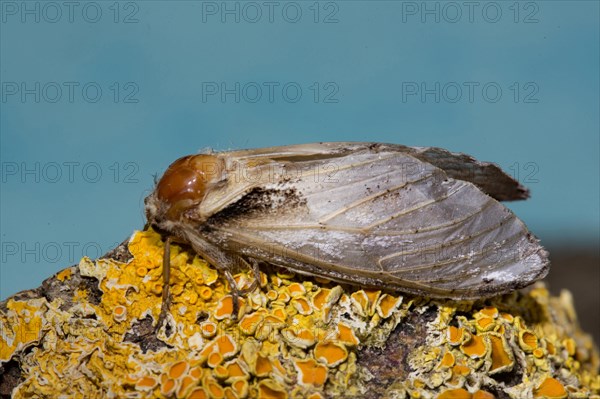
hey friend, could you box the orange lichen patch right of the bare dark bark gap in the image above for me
[401,292,600,399]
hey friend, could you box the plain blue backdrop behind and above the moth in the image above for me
[0,1,600,299]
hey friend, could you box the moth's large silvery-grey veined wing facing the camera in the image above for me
[203,143,548,298]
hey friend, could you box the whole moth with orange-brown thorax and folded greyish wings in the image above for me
[145,142,549,324]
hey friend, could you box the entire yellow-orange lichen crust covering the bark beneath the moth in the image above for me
[0,230,600,399]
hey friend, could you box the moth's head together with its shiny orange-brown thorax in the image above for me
[145,154,225,229]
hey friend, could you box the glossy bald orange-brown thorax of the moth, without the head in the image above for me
[156,154,225,221]
